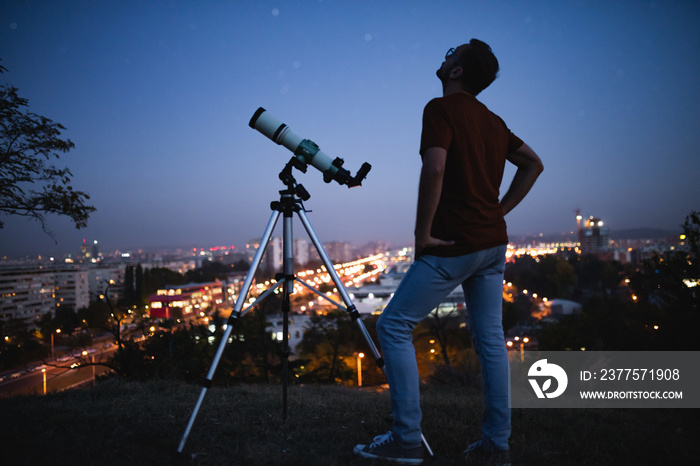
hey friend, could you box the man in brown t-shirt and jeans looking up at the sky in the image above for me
[354,39,543,464]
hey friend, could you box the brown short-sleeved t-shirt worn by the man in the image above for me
[420,93,523,257]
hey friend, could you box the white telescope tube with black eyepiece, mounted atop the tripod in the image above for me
[249,107,372,188]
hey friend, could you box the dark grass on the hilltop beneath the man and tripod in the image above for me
[0,380,700,466]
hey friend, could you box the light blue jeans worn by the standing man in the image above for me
[377,245,510,449]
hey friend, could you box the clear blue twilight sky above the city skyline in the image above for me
[0,0,700,256]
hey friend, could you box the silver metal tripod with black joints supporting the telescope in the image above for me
[177,157,433,456]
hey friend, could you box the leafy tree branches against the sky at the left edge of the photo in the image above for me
[0,62,95,237]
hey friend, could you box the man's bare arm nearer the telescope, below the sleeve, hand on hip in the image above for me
[415,147,453,256]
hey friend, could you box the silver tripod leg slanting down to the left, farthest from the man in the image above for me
[177,211,280,453]
